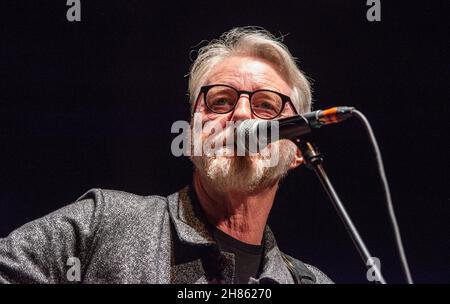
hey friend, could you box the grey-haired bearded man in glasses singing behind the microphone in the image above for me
[0,28,331,283]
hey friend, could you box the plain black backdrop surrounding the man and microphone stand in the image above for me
[0,0,450,283]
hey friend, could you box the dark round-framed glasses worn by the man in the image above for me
[196,84,298,119]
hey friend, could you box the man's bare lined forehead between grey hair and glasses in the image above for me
[207,56,291,95]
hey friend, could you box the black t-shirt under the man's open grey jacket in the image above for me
[213,228,263,284]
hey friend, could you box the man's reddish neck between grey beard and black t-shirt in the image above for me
[194,172,278,245]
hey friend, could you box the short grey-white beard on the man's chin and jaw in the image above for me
[191,124,297,194]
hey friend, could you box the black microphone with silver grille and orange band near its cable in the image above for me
[235,106,355,153]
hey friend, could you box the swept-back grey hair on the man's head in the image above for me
[189,27,311,113]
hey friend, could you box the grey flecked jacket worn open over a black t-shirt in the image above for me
[0,187,332,283]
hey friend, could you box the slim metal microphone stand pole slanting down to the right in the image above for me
[294,139,386,284]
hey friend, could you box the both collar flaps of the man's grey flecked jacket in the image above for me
[167,186,302,284]
